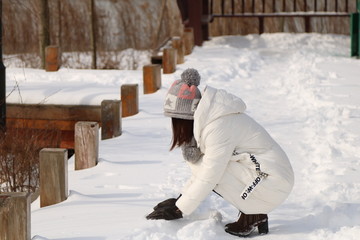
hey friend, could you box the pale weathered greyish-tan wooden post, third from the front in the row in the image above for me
[75,122,99,170]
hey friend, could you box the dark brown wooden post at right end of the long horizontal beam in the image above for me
[101,100,121,140]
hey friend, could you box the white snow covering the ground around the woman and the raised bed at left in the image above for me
[6,33,360,240]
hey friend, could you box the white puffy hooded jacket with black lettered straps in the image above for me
[176,86,294,215]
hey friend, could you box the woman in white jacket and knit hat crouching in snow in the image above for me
[147,69,294,237]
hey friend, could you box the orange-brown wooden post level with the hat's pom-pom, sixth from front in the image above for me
[143,64,161,94]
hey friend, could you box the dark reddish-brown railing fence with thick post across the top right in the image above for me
[177,0,357,46]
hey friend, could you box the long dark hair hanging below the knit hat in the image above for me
[170,118,194,150]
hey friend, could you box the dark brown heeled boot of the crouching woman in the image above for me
[225,213,269,237]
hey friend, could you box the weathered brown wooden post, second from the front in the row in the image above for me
[40,148,68,207]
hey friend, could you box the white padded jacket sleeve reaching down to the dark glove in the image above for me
[176,119,235,215]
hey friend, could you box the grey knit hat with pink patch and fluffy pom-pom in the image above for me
[164,68,201,120]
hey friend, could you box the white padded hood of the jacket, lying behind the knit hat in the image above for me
[194,86,246,141]
